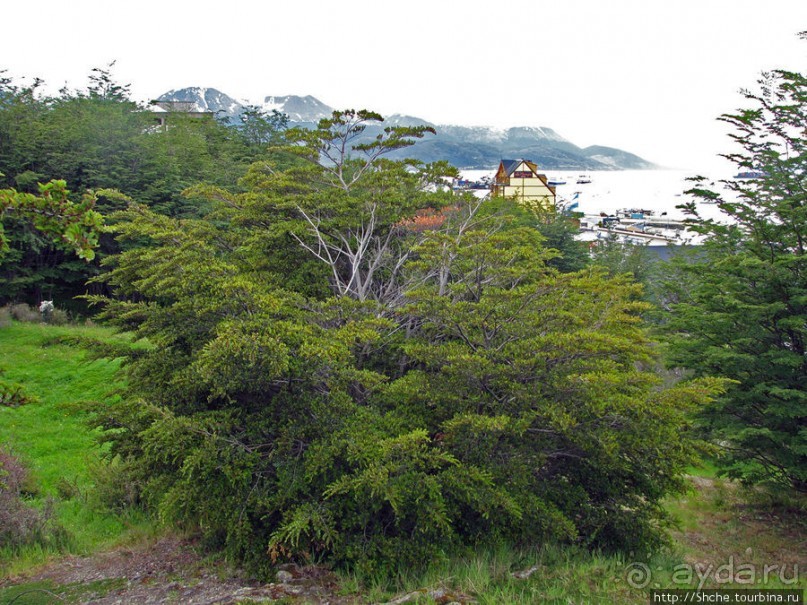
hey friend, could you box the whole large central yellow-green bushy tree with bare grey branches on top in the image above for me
[83,111,720,569]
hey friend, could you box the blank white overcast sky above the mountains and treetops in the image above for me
[0,0,807,170]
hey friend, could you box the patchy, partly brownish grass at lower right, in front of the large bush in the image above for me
[332,468,807,605]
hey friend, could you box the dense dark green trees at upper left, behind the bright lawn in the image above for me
[0,66,286,305]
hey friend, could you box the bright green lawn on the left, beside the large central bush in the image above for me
[0,322,156,573]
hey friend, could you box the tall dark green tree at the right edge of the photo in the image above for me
[669,65,807,491]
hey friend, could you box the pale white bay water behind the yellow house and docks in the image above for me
[462,169,722,224]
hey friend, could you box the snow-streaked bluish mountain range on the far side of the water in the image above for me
[158,87,657,170]
